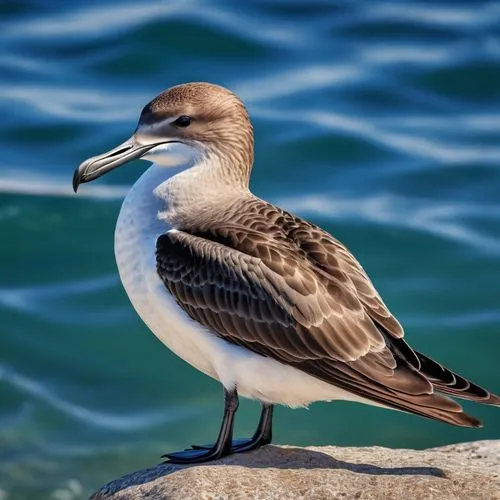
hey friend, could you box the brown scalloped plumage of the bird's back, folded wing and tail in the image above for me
[156,197,500,426]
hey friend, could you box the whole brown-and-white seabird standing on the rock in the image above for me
[73,82,500,464]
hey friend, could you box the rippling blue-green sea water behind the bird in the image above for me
[0,0,500,500]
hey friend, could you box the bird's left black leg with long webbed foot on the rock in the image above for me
[162,388,239,464]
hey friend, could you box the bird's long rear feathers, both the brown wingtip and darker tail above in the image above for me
[300,335,500,427]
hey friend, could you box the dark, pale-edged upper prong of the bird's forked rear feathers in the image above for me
[414,351,500,406]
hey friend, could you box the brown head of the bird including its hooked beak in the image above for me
[73,82,253,192]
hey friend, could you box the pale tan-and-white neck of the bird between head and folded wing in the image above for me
[152,155,251,229]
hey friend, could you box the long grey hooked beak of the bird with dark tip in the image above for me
[73,136,158,193]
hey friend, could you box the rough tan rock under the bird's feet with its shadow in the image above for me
[91,440,500,500]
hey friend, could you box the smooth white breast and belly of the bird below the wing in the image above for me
[115,165,367,407]
